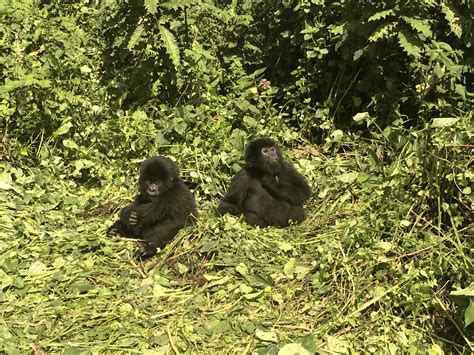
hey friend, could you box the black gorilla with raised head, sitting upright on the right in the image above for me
[217,138,311,227]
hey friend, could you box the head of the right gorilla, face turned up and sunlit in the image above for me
[245,137,283,175]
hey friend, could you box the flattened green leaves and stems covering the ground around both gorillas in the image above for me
[0,152,468,354]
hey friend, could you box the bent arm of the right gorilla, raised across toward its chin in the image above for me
[261,163,311,206]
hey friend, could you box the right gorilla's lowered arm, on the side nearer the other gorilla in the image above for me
[217,169,249,216]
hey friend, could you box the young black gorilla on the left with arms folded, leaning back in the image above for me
[107,156,197,258]
